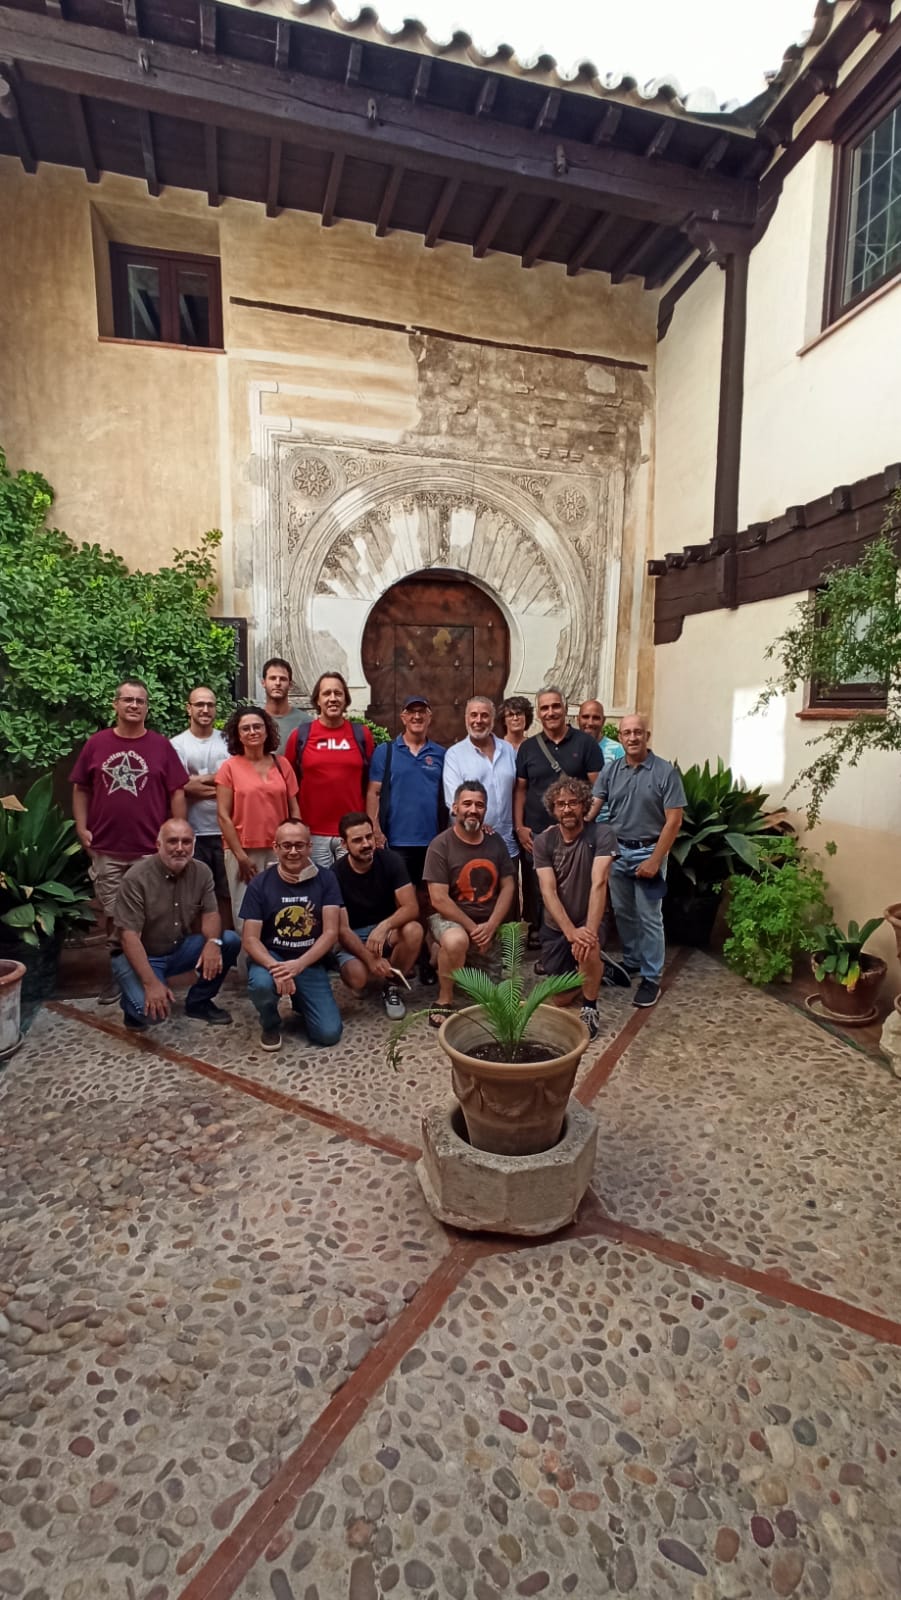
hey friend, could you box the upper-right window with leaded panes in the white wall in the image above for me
[824,82,901,325]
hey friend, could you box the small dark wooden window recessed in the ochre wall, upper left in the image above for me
[109,245,222,349]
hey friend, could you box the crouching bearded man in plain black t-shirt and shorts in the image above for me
[334,811,422,1022]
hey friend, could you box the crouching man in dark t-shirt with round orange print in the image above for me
[422,778,515,1027]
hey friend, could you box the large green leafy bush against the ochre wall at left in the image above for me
[0,451,235,776]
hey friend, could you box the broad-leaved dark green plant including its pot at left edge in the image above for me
[0,773,91,1030]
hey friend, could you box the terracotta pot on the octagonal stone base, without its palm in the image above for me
[438,1005,589,1155]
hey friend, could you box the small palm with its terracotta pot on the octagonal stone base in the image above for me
[389,923,589,1155]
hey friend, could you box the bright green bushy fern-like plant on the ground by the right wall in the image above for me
[723,838,832,984]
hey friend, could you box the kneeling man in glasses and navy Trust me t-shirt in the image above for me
[240,822,341,1050]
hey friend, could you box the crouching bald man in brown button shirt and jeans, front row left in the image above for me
[112,818,242,1030]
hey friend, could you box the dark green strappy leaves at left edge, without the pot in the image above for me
[0,773,91,949]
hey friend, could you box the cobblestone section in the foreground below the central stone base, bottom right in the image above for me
[238,1243,901,1600]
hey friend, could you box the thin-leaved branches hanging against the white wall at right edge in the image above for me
[759,490,901,827]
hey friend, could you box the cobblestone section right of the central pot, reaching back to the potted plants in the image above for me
[594,955,901,1317]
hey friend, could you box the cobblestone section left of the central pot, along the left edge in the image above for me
[0,1013,446,1600]
